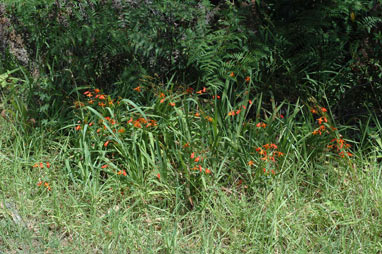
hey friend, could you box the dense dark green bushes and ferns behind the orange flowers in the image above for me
[1,0,382,120]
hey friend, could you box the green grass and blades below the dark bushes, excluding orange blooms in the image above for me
[0,81,382,253]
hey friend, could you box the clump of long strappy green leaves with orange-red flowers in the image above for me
[63,74,352,199]
